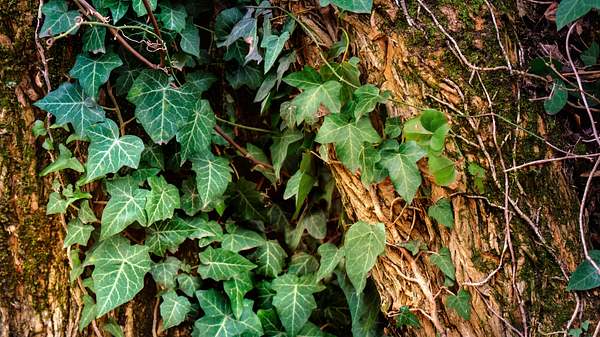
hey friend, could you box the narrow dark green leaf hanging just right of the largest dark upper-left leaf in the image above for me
[176,99,216,164]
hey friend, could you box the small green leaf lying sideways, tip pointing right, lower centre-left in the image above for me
[198,247,256,281]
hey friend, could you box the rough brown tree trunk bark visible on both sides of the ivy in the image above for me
[0,0,597,337]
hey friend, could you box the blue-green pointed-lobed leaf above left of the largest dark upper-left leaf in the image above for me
[69,51,123,98]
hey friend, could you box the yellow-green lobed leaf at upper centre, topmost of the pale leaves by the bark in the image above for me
[292,81,342,125]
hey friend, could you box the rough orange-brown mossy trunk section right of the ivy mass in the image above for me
[282,0,598,336]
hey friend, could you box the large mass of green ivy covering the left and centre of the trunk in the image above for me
[33,0,470,337]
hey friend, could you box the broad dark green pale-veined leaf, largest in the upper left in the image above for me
[127,69,195,144]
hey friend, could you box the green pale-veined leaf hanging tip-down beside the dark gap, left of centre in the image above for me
[192,153,231,208]
